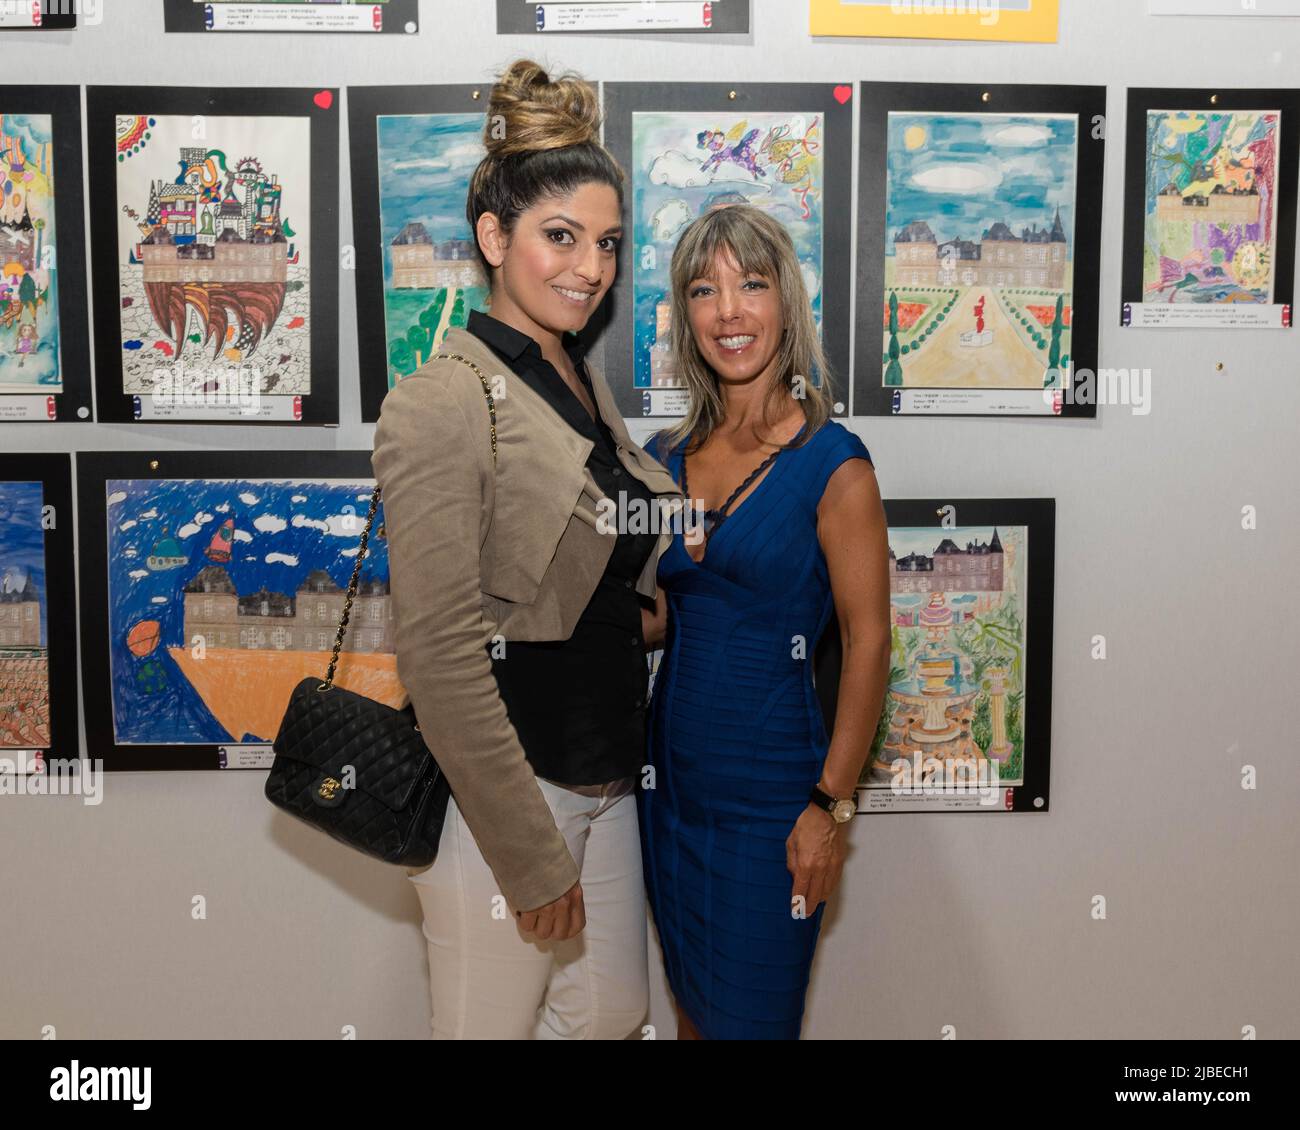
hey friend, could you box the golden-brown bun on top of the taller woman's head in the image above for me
[484,59,601,160]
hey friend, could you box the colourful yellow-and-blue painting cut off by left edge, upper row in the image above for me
[0,107,64,394]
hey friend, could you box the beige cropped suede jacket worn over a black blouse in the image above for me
[372,328,681,910]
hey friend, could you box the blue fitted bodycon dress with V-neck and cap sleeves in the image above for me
[638,420,871,1039]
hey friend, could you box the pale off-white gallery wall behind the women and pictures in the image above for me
[0,0,1300,1039]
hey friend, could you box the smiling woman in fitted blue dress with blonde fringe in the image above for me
[638,205,889,1039]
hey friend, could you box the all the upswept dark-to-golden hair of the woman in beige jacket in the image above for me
[465,59,624,278]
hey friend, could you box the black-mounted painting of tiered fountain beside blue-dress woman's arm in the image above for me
[814,498,1056,813]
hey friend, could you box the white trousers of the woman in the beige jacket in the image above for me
[407,778,650,1040]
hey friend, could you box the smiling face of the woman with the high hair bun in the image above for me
[478,181,623,338]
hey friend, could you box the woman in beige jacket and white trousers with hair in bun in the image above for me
[373,60,680,1039]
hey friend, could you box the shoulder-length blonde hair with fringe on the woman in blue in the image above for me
[660,204,832,451]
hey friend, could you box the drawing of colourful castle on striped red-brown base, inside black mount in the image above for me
[116,114,312,395]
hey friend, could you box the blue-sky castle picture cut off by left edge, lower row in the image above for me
[0,481,49,758]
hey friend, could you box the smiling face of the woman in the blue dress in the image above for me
[686,244,785,384]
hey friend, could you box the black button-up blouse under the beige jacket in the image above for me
[465,309,657,785]
